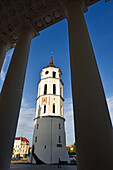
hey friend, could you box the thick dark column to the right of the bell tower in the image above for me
[65,0,113,170]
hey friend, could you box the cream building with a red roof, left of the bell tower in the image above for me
[12,137,29,158]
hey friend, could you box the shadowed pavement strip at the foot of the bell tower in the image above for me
[10,163,77,170]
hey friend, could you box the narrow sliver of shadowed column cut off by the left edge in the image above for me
[0,41,7,72]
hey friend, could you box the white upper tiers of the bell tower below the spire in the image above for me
[36,67,64,117]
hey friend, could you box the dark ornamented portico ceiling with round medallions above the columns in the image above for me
[0,0,99,48]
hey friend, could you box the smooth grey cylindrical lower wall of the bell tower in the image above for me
[32,116,69,164]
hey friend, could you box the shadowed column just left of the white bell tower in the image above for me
[0,27,33,170]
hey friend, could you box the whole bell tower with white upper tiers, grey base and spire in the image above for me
[31,52,69,164]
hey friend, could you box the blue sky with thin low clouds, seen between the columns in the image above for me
[0,0,113,145]
